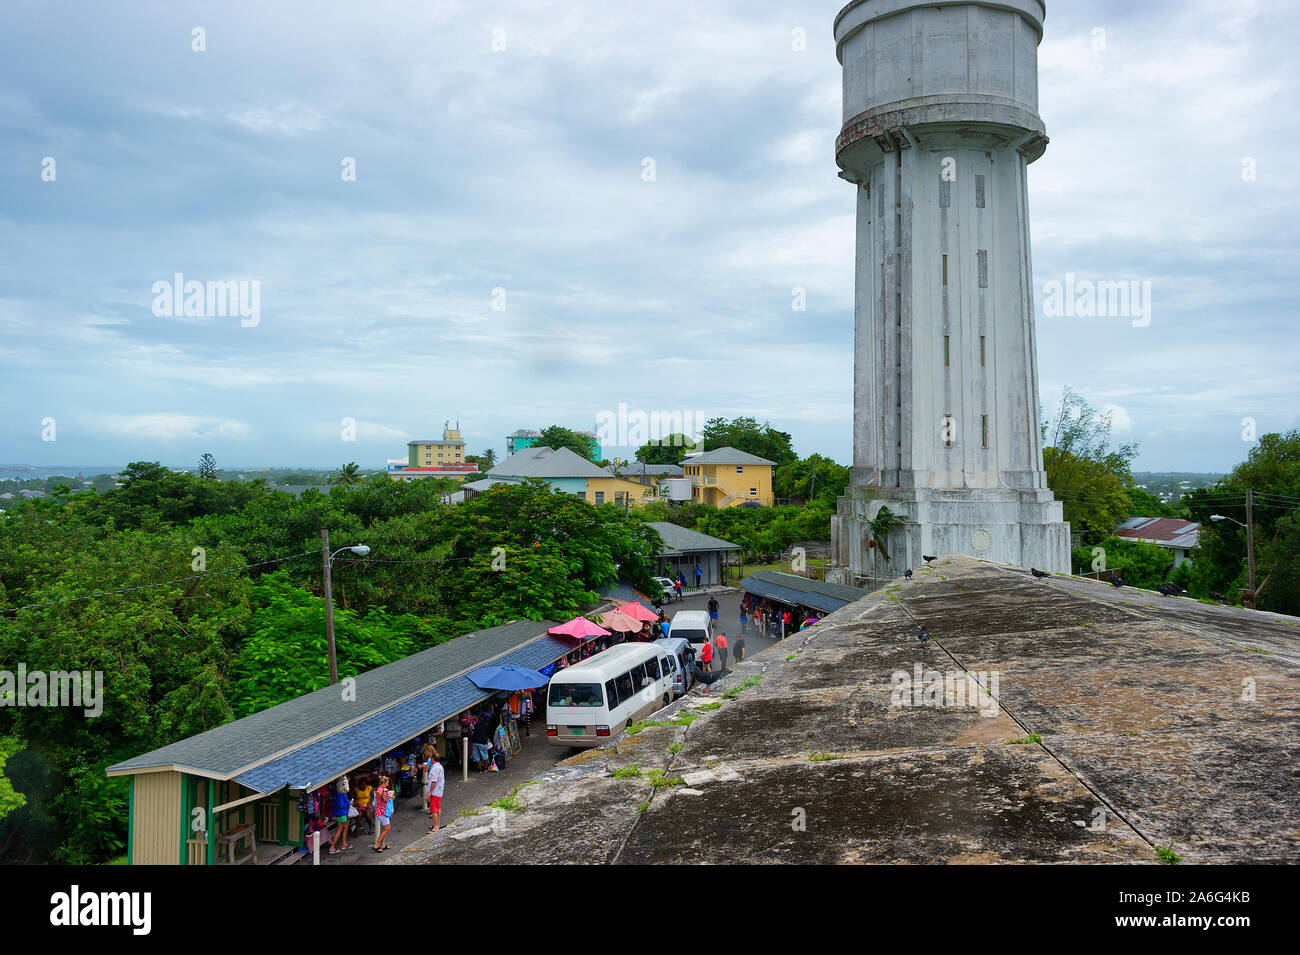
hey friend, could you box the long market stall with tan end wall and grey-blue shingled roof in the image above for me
[107,620,595,865]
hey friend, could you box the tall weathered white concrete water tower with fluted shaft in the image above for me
[832,0,1070,583]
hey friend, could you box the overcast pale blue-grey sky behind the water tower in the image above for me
[0,0,1300,470]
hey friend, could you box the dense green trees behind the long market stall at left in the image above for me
[0,463,659,863]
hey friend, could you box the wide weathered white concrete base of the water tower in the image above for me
[827,485,1070,589]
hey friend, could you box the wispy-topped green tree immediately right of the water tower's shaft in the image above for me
[1043,387,1138,543]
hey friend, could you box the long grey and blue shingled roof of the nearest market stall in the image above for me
[107,620,572,793]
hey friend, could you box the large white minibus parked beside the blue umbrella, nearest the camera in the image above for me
[546,643,673,746]
